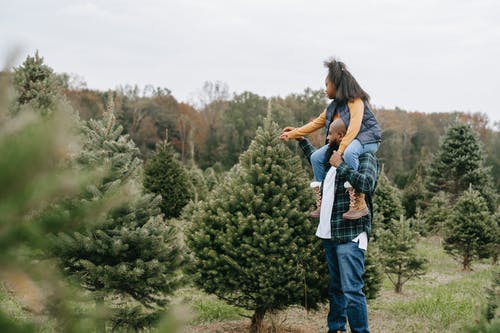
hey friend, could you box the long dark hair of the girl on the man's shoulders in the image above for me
[325,59,370,102]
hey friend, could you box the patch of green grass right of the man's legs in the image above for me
[370,238,492,333]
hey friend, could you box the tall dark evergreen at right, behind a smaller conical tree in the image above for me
[427,124,497,213]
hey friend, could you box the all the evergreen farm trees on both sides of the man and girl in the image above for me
[0,53,500,332]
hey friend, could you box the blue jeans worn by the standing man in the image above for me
[323,239,370,333]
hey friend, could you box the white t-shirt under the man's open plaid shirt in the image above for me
[316,167,368,251]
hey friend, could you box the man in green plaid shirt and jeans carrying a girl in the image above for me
[299,119,380,333]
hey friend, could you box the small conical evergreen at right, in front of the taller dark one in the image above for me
[444,188,498,270]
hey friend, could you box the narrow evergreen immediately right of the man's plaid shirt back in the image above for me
[373,169,403,229]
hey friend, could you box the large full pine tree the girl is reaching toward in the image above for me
[187,120,328,332]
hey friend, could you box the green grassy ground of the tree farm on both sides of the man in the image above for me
[177,237,493,333]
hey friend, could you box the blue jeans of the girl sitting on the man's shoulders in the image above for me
[311,139,379,182]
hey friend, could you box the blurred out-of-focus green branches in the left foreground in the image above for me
[0,54,154,332]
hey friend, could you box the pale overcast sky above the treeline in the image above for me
[0,0,500,120]
